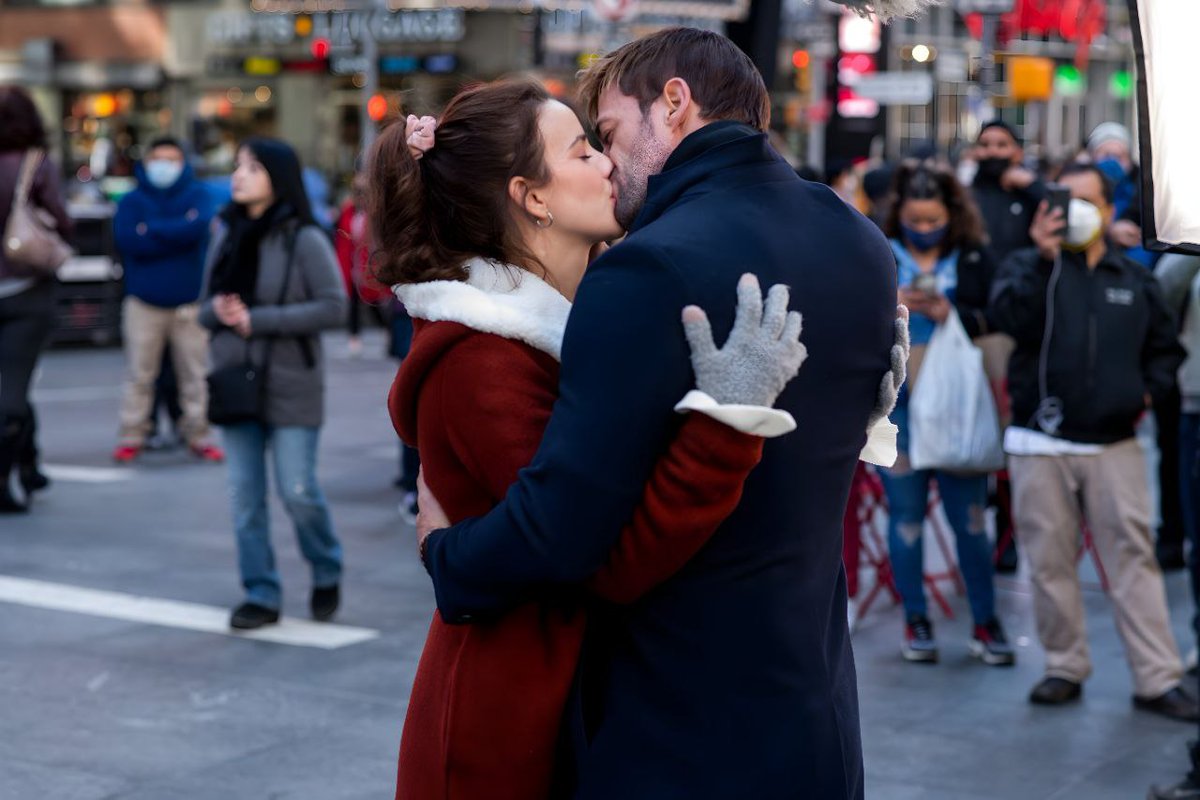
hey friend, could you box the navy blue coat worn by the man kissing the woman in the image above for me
[426,122,896,800]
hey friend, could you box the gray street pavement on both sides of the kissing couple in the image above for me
[0,335,1195,800]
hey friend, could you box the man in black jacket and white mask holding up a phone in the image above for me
[991,164,1200,722]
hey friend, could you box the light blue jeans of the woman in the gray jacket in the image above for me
[222,422,342,609]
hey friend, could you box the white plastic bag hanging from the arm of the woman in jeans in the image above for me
[908,309,1004,473]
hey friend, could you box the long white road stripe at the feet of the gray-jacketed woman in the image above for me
[0,576,379,650]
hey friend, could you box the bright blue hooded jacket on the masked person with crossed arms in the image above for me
[113,164,216,308]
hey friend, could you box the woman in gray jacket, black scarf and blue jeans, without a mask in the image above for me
[200,139,346,630]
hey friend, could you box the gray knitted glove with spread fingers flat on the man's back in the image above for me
[683,273,809,407]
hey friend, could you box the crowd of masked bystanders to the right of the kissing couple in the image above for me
[825,120,1200,720]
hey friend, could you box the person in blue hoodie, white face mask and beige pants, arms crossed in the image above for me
[113,137,224,463]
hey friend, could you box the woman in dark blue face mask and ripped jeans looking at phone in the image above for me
[881,163,1015,666]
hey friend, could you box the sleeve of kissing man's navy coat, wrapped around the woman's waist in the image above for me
[425,242,696,622]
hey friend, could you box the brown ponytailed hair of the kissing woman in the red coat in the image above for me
[367,80,551,285]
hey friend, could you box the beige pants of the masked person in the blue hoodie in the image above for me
[120,297,209,446]
